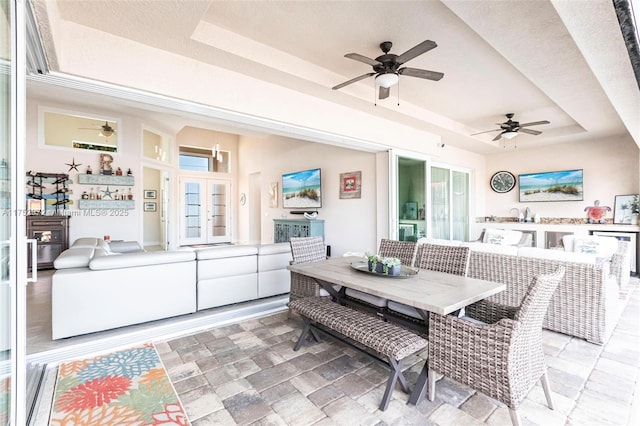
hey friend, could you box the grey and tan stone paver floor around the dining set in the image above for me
[156,278,640,426]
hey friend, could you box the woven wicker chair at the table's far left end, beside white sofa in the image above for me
[289,237,327,302]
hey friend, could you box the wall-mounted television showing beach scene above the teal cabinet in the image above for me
[282,169,322,209]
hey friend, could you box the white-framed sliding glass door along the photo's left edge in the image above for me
[0,0,27,425]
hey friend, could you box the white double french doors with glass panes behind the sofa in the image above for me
[180,177,231,246]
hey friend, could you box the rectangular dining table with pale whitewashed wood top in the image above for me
[289,257,506,404]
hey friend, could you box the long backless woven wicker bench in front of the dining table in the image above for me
[289,297,427,411]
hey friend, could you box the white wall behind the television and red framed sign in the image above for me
[238,136,386,256]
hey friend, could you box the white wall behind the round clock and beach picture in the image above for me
[488,138,640,220]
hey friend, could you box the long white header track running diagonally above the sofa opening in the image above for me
[27,71,389,152]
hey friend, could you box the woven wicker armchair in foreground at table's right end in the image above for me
[427,266,564,425]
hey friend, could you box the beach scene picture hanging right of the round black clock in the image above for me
[519,170,583,202]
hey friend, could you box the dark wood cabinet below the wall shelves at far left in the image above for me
[27,216,69,269]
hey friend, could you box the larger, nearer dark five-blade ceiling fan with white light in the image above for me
[332,40,444,99]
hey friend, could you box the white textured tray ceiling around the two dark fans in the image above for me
[31,0,640,153]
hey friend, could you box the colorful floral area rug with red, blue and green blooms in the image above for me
[49,344,189,426]
